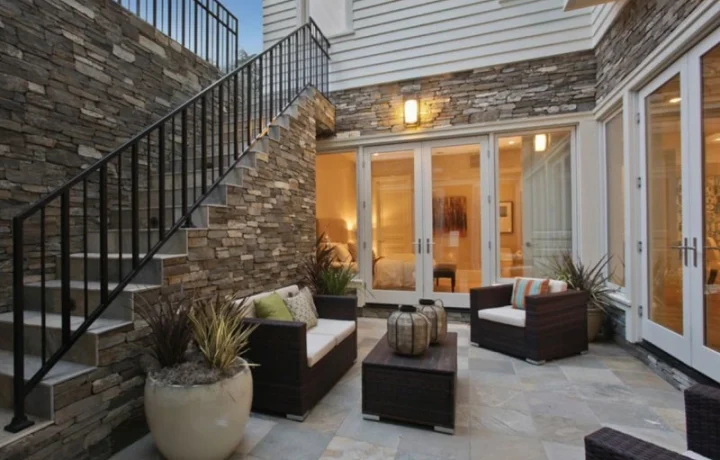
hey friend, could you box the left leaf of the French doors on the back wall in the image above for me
[366,145,422,304]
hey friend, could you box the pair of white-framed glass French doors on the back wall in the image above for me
[362,137,489,307]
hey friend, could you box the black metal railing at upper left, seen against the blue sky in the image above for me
[112,0,239,71]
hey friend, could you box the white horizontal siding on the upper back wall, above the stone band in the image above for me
[263,0,600,90]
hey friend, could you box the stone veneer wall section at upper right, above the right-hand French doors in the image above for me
[595,0,703,101]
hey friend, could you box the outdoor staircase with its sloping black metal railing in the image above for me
[0,21,330,433]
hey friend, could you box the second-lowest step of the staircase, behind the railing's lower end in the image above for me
[0,350,95,420]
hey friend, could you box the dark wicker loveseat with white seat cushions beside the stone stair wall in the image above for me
[244,286,357,421]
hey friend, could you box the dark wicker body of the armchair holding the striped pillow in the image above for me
[470,284,588,364]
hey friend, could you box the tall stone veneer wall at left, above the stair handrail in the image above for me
[0,0,220,312]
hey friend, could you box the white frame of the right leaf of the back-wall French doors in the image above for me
[421,136,495,308]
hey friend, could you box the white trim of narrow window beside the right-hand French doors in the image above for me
[598,105,632,305]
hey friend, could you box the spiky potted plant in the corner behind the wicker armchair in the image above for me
[550,253,616,342]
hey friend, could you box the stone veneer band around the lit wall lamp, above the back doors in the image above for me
[330,51,596,136]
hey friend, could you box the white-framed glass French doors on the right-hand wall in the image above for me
[640,28,720,379]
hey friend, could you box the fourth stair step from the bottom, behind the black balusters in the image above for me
[25,280,161,321]
